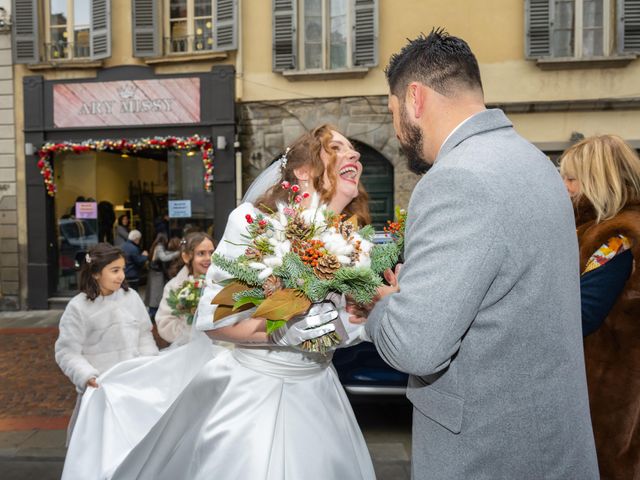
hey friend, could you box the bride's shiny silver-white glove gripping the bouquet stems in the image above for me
[269,301,338,347]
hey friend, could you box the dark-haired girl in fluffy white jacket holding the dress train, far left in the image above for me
[55,243,158,437]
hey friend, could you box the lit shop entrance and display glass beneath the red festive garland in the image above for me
[52,149,214,296]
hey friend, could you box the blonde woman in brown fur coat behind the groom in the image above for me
[560,135,640,479]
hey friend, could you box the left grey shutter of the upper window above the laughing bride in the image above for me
[273,0,298,72]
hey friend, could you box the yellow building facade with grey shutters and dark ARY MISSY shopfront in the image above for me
[8,0,640,308]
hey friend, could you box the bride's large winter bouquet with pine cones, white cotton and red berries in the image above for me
[212,182,388,352]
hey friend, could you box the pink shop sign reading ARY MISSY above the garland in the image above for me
[53,77,200,128]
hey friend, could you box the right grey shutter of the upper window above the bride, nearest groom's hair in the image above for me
[353,0,378,67]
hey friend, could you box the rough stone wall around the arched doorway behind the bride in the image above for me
[238,96,419,207]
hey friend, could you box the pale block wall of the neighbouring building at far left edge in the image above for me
[0,20,20,310]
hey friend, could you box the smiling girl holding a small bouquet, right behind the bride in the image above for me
[155,232,214,345]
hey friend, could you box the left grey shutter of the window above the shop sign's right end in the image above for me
[132,0,162,57]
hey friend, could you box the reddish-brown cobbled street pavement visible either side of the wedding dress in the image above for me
[0,311,411,480]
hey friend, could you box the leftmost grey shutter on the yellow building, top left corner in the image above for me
[11,0,40,63]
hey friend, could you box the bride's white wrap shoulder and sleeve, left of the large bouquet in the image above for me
[195,203,256,330]
